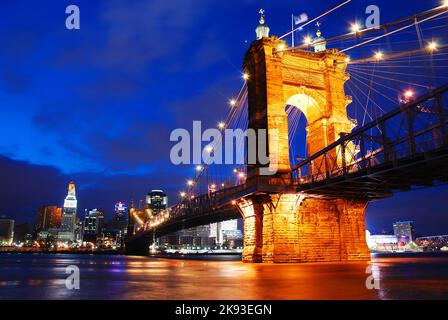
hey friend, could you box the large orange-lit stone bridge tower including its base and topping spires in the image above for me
[238,11,370,262]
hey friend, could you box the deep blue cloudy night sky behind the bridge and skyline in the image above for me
[0,0,448,234]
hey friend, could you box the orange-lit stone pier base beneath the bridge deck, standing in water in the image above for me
[239,194,370,263]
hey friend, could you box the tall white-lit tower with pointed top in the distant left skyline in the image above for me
[58,182,78,241]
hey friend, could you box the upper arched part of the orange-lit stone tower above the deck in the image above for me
[244,37,354,178]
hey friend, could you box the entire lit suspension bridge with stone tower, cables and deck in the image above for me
[126,1,448,262]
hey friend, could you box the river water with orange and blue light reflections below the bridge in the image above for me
[0,255,448,300]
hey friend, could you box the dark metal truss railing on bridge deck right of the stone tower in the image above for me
[292,85,448,185]
